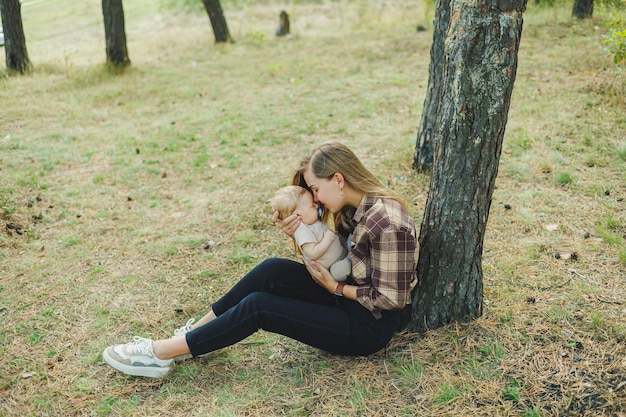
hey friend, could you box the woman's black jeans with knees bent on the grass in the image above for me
[186,258,402,356]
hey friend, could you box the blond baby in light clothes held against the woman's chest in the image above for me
[270,185,352,282]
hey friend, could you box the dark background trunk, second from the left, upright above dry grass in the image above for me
[102,0,130,68]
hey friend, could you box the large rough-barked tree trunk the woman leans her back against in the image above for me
[409,0,527,331]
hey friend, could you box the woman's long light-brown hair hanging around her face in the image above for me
[292,142,406,227]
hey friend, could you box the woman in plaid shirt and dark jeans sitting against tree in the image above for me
[102,143,418,378]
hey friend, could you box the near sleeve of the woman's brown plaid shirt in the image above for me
[357,229,417,311]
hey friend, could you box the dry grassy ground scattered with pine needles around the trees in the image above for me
[0,0,626,416]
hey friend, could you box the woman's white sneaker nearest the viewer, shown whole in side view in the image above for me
[102,336,174,378]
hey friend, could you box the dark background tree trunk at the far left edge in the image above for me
[0,0,32,74]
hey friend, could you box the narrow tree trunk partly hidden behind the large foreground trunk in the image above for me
[413,0,450,173]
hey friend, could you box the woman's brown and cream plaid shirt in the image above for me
[349,197,419,316]
